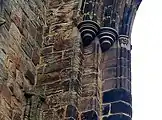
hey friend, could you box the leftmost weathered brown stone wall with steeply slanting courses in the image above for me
[0,0,45,120]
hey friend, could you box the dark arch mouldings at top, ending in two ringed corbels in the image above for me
[78,0,142,52]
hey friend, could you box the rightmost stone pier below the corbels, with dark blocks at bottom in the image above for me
[102,36,132,120]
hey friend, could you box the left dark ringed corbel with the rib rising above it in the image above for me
[77,0,100,47]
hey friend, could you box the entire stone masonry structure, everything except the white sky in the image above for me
[0,0,141,120]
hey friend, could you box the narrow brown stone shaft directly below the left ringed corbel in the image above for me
[79,41,102,120]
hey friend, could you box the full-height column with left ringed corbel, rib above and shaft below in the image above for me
[77,0,102,120]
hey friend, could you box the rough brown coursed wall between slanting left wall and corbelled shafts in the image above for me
[37,0,82,120]
